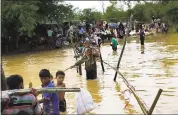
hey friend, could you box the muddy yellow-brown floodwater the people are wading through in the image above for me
[2,34,178,114]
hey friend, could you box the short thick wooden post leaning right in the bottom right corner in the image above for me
[148,89,163,115]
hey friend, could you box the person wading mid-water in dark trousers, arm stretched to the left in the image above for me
[71,39,99,79]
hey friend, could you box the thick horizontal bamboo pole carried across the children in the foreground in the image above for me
[2,88,80,95]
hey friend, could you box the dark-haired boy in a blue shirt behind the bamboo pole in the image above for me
[39,69,59,115]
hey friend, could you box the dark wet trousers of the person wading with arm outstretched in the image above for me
[86,62,97,79]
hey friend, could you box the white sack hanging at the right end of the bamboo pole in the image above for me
[76,89,96,114]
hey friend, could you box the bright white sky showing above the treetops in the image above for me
[65,1,136,12]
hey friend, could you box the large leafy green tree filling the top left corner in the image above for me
[1,1,38,48]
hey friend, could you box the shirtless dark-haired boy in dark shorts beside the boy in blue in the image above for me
[56,70,66,112]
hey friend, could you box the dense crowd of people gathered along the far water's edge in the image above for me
[27,19,168,53]
